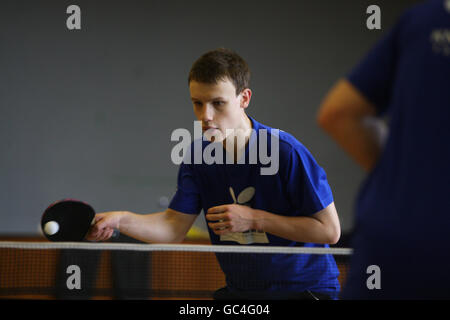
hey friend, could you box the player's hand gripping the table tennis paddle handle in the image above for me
[86,211,126,241]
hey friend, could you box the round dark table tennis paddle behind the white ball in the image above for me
[41,199,119,242]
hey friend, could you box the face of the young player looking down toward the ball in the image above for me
[189,79,250,138]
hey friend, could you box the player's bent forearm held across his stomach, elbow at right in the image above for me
[254,210,340,244]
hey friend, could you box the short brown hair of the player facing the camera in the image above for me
[188,48,250,95]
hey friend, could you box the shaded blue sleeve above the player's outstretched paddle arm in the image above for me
[169,163,202,214]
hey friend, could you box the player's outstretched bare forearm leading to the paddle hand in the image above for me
[119,211,185,243]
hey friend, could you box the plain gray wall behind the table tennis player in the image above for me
[0,0,415,235]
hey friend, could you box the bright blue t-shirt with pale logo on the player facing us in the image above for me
[169,118,340,298]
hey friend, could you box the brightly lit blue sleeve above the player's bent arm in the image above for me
[287,145,333,216]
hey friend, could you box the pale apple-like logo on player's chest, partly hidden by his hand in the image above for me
[220,187,269,244]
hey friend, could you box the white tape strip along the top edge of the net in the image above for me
[0,241,353,255]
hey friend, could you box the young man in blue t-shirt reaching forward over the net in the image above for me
[89,49,340,299]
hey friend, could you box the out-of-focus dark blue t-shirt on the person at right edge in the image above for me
[342,0,450,299]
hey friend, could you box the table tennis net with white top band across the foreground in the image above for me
[0,241,351,300]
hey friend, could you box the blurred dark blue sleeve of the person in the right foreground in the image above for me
[347,15,404,115]
